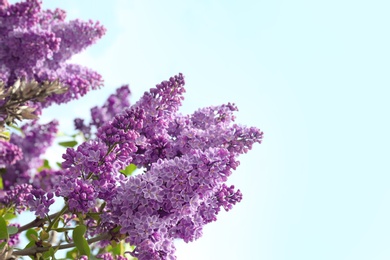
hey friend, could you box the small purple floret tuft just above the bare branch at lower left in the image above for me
[26,188,54,218]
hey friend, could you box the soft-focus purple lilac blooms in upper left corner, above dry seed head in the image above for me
[0,0,105,107]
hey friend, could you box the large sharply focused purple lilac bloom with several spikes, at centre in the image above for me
[57,74,262,260]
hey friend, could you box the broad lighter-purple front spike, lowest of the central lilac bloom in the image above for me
[103,148,236,260]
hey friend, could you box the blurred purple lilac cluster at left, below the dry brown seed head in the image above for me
[2,120,58,190]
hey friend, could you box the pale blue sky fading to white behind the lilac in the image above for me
[9,0,390,260]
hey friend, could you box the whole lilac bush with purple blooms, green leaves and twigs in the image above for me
[0,0,263,260]
